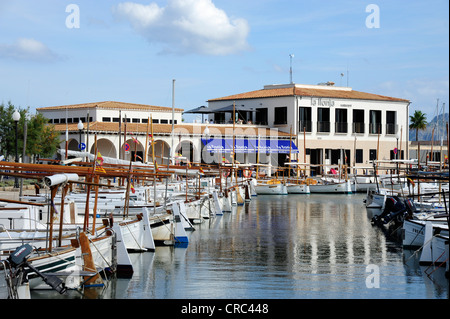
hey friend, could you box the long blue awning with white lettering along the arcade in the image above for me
[202,138,298,154]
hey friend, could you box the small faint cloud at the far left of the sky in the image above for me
[0,38,59,62]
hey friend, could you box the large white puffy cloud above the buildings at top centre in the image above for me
[113,0,249,55]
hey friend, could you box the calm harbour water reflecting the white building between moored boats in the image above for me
[33,195,449,299]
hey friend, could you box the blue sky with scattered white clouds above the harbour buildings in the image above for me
[0,0,449,122]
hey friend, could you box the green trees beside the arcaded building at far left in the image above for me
[0,102,61,162]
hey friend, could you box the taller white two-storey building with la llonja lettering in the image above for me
[208,83,410,174]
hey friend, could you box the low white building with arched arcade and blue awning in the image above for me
[37,101,295,170]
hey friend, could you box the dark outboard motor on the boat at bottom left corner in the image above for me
[7,244,67,294]
